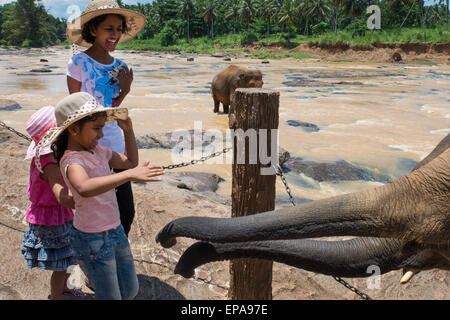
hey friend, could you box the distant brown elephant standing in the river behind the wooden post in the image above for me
[211,65,264,113]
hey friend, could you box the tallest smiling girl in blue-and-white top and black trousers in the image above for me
[66,0,145,235]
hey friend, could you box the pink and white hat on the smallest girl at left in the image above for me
[24,106,56,160]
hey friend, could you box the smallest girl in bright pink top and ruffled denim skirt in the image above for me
[21,106,82,300]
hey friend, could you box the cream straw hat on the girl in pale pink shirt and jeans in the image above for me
[34,92,128,172]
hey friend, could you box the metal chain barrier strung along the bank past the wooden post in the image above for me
[0,121,372,300]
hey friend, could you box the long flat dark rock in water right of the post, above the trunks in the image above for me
[283,157,390,183]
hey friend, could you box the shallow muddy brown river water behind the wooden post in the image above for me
[0,47,450,201]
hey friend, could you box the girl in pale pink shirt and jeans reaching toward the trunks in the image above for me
[36,92,164,300]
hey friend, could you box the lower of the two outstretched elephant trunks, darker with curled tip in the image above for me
[175,238,413,278]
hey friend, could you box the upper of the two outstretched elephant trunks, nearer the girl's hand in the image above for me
[156,149,450,247]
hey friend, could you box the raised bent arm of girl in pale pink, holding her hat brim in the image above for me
[109,117,139,169]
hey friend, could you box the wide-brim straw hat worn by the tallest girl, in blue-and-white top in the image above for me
[66,0,146,47]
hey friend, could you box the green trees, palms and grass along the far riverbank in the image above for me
[0,0,450,52]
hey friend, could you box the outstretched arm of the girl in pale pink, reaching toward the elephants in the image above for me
[67,161,165,197]
